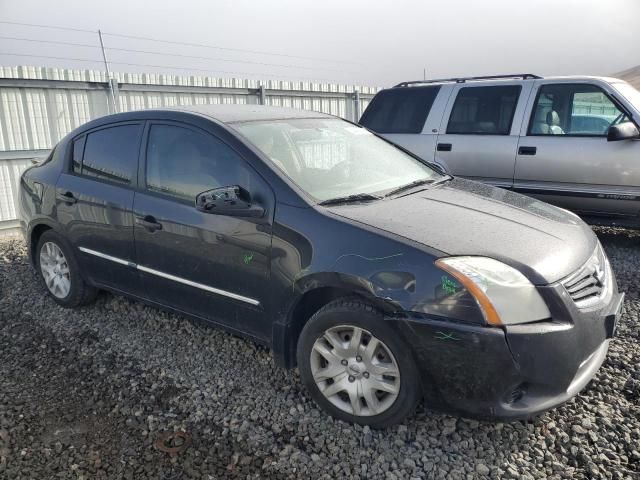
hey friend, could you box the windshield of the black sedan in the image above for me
[233,118,443,202]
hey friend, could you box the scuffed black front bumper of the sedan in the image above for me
[397,281,624,420]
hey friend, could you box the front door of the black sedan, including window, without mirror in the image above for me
[133,122,274,339]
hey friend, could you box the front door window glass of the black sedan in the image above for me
[146,124,254,203]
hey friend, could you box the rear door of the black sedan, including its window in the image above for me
[56,122,142,294]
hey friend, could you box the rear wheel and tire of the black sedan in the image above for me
[35,230,98,308]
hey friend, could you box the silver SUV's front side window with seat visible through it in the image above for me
[528,83,627,137]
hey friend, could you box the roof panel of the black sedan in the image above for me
[168,104,333,123]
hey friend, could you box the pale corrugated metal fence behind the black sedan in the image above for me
[0,67,378,228]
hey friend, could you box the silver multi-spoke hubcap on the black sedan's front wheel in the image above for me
[310,325,400,417]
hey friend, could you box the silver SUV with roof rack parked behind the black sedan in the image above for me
[360,74,640,225]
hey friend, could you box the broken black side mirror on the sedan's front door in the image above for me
[196,185,264,218]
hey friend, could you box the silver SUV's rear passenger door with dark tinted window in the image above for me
[435,82,531,188]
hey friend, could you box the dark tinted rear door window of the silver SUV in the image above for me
[447,85,522,135]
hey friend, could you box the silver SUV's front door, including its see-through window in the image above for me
[514,80,640,217]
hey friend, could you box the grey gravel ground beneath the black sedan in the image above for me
[0,229,640,480]
